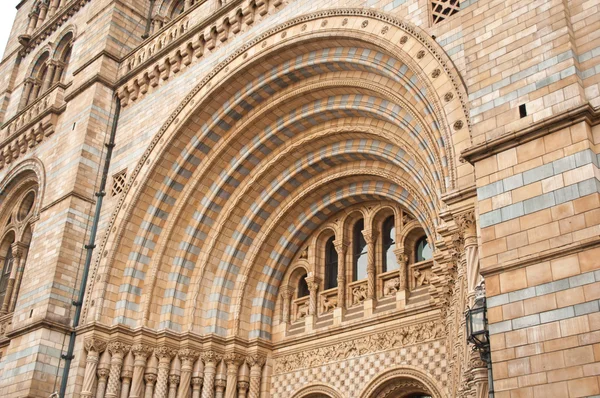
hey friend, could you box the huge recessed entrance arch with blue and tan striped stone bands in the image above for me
[87,10,470,339]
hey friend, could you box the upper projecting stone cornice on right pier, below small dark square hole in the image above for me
[460,103,600,164]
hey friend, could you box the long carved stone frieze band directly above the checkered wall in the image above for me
[275,321,444,374]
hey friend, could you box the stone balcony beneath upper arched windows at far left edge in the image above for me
[0,83,67,169]
